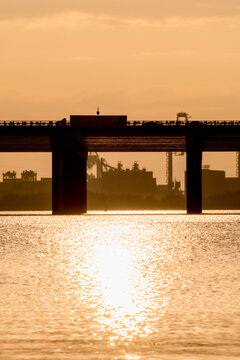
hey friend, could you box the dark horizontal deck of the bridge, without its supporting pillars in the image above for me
[0,125,240,152]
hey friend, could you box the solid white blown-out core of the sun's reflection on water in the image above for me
[86,238,165,346]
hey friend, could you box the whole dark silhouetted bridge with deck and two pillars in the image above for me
[0,115,240,215]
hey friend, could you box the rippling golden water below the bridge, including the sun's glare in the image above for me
[0,212,240,360]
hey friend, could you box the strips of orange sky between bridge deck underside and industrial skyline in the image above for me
[0,152,236,188]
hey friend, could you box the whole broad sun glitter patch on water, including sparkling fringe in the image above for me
[63,219,171,359]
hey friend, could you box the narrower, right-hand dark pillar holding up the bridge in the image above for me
[186,138,202,214]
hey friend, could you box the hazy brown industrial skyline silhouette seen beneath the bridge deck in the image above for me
[0,163,240,210]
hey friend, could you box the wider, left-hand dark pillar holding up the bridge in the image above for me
[52,140,87,215]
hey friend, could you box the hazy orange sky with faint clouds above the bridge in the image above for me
[0,0,240,183]
